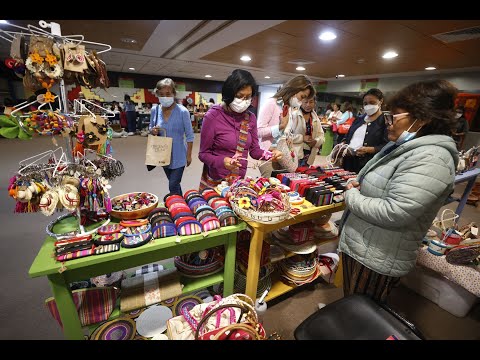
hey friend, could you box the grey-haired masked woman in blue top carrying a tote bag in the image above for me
[147,78,194,195]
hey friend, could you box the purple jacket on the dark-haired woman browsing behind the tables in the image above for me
[198,105,263,180]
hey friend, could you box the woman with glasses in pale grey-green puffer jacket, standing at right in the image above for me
[338,80,458,302]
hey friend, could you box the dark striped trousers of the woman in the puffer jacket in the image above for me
[342,253,400,302]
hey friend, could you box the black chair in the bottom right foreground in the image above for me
[294,294,424,340]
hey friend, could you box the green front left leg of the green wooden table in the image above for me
[48,274,84,340]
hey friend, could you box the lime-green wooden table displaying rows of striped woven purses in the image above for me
[28,217,246,340]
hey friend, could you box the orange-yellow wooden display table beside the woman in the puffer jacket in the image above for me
[243,201,345,301]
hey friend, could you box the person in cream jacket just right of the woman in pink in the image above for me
[292,92,325,166]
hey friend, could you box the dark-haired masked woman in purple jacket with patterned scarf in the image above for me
[198,69,282,189]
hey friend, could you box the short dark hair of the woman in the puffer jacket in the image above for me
[389,80,458,136]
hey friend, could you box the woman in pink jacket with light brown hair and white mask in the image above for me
[258,75,315,177]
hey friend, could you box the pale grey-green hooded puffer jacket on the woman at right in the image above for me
[339,135,458,277]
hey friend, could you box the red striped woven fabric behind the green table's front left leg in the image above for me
[45,287,117,328]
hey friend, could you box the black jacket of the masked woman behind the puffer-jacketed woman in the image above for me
[343,114,389,173]
